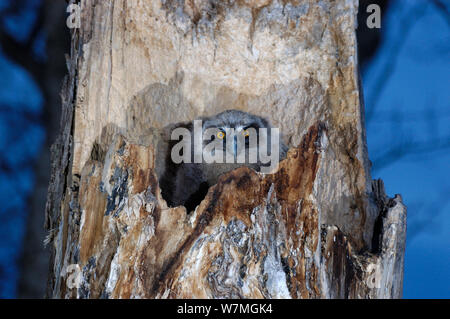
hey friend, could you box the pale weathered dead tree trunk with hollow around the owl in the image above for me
[46,0,406,298]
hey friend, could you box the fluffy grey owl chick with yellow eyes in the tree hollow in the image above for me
[160,110,287,211]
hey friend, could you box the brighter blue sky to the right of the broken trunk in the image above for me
[363,0,450,298]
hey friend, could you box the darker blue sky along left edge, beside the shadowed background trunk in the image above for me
[0,0,45,298]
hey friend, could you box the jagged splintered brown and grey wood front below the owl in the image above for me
[48,125,405,298]
